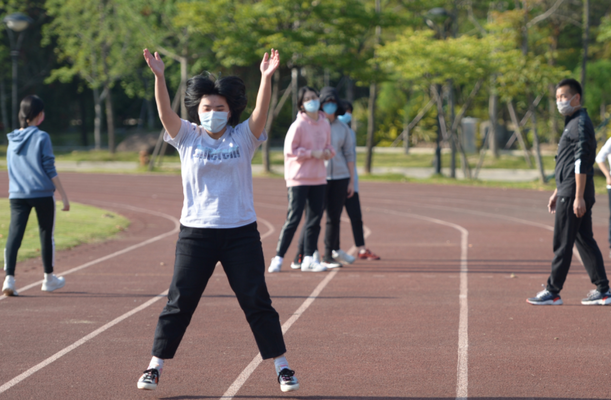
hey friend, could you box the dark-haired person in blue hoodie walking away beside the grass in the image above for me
[2,95,70,296]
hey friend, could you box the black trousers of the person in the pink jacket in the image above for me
[276,185,327,257]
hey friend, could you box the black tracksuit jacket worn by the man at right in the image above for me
[556,108,596,199]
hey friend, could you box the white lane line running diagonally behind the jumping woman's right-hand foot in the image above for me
[221,209,371,400]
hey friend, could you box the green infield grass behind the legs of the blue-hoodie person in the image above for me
[0,202,130,264]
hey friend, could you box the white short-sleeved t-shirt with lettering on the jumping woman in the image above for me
[163,120,267,228]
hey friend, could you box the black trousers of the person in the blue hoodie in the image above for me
[4,196,55,276]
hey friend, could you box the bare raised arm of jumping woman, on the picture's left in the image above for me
[144,49,182,138]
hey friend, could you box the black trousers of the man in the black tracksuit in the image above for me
[547,197,609,293]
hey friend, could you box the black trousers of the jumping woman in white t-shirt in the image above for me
[152,222,286,359]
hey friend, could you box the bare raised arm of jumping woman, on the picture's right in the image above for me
[248,49,280,139]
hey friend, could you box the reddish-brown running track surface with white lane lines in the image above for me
[0,173,611,400]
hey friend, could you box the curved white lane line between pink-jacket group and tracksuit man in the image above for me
[370,207,469,400]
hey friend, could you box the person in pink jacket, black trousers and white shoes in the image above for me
[268,86,335,272]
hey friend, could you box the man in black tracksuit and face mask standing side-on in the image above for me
[526,79,611,305]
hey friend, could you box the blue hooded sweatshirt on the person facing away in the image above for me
[6,126,57,199]
